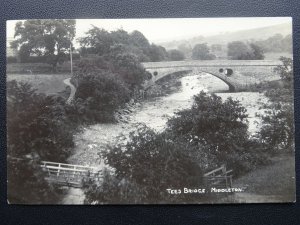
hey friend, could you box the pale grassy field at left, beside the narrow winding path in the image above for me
[6,74,71,95]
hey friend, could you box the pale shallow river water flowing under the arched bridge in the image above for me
[63,73,267,204]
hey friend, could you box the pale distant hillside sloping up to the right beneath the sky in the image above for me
[158,23,292,49]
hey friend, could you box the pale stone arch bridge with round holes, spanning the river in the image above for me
[143,60,282,92]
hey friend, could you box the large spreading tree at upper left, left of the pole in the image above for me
[11,19,76,69]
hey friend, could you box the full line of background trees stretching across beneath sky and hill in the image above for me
[7,19,292,71]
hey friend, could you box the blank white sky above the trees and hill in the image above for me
[7,17,292,43]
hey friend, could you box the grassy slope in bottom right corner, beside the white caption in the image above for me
[232,154,295,203]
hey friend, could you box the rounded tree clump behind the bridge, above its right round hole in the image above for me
[227,41,264,60]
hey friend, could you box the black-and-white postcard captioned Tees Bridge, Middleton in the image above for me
[6,17,296,205]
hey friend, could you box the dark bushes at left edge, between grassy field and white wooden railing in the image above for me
[7,80,73,161]
